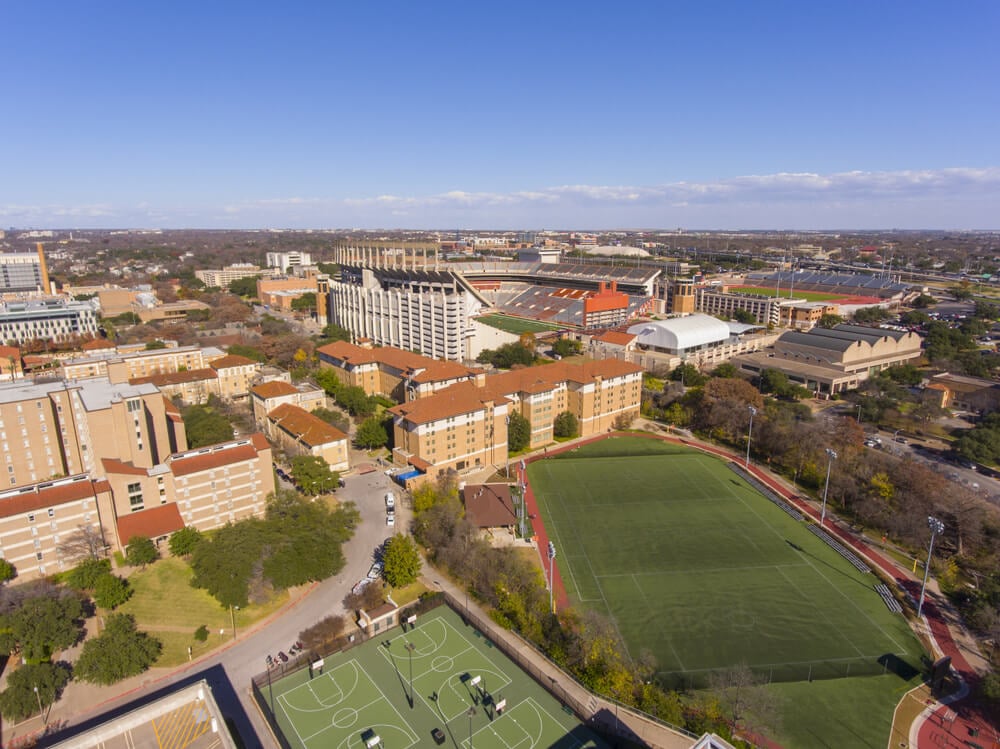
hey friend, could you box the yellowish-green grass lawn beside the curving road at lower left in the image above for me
[118,557,288,666]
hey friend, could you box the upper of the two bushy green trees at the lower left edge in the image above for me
[0,586,83,663]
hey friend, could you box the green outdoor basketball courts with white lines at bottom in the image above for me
[261,606,606,749]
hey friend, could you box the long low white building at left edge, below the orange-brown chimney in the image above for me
[0,298,97,344]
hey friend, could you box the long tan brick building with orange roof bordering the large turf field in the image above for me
[389,359,642,476]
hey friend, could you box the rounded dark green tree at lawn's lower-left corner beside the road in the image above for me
[76,614,163,685]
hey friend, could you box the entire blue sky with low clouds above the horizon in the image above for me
[0,0,1000,229]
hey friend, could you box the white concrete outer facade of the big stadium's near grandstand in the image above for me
[328,266,483,361]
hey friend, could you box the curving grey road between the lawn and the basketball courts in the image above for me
[39,471,411,749]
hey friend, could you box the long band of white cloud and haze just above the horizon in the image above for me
[0,167,1000,229]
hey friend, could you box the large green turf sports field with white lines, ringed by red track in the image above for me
[528,437,922,687]
